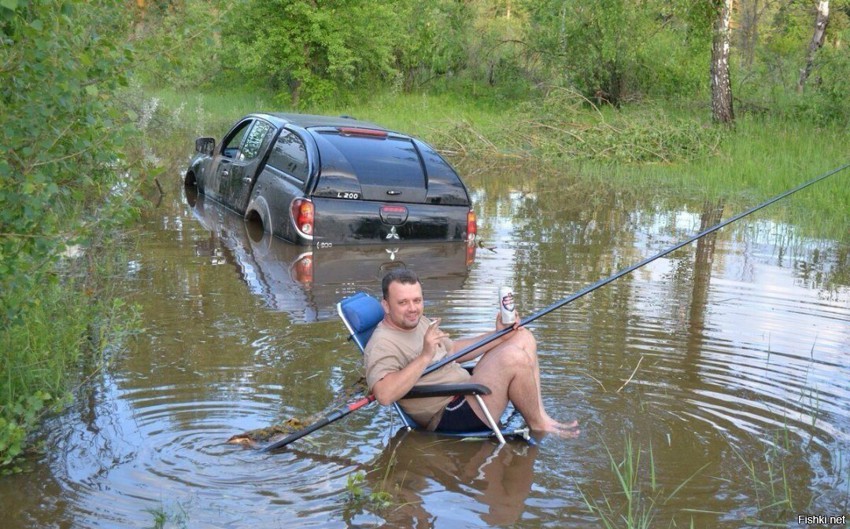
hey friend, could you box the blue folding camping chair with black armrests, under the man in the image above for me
[337,292,529,445]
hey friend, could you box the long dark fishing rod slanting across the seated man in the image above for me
[263,163,850,451]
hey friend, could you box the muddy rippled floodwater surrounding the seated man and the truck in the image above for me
[0,158,850,529]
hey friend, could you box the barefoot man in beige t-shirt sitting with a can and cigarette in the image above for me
[364,269,578,436]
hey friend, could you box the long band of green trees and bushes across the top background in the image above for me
[137,0,850,122]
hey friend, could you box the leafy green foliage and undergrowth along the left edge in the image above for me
[0,0,141,470]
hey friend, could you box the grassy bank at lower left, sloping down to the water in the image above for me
[0,233,136,474]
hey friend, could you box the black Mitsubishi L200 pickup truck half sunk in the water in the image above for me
[184,113,477,248]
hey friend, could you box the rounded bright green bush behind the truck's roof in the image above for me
[222,0,403,106]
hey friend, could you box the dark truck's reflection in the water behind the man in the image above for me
[185,187,475,322]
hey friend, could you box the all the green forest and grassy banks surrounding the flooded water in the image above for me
[0,0,850,472]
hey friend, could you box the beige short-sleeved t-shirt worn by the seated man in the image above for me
[363,316,470,430]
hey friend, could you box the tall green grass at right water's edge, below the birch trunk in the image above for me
[583,118,850,242]
